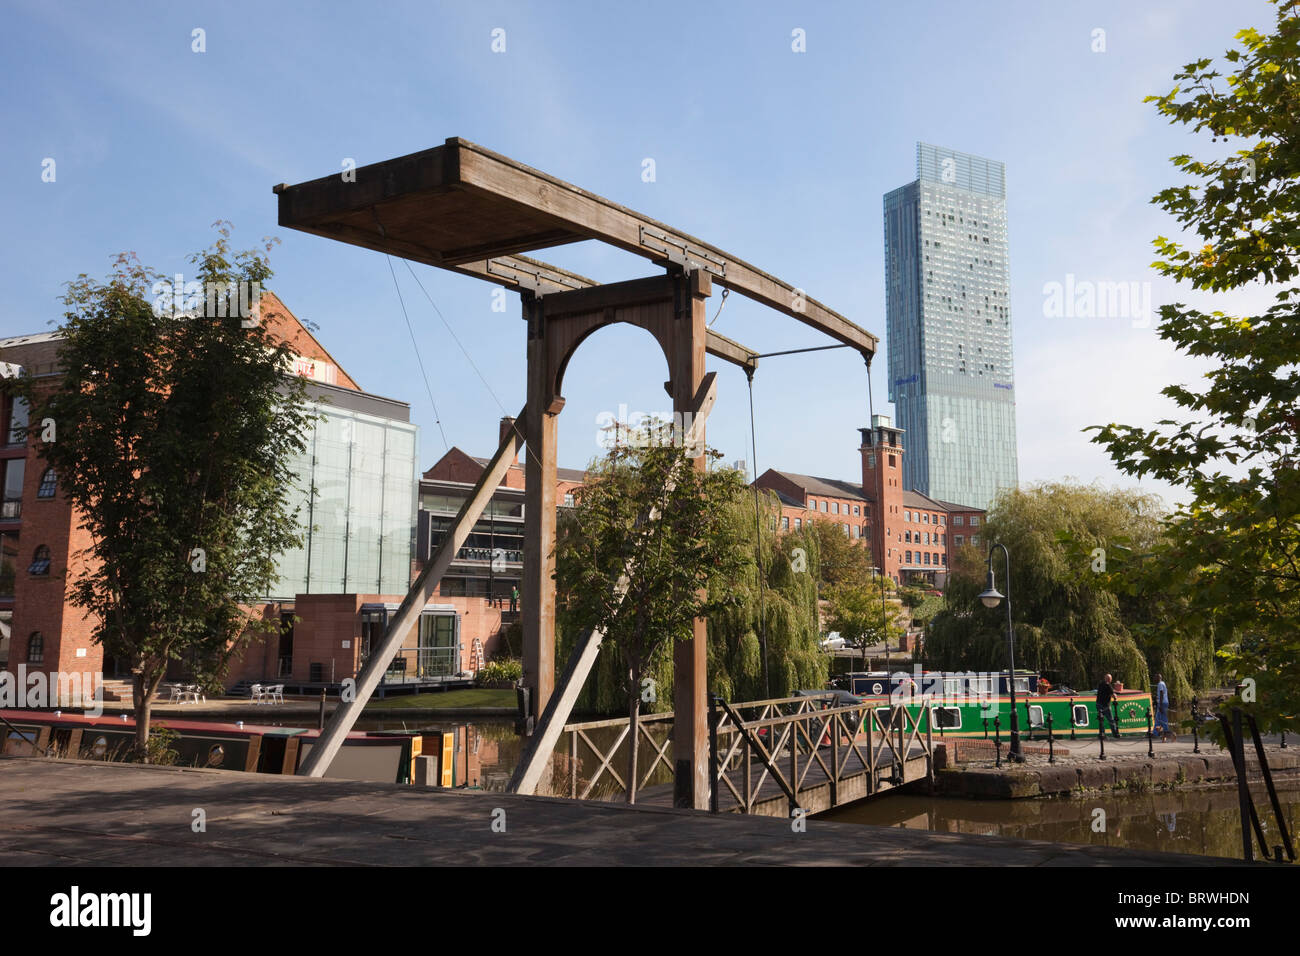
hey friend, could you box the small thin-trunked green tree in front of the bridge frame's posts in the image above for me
[555,444,745,804]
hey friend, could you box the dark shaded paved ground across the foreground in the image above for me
[0,757,1235,866]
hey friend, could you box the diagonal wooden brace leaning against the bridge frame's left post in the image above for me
[298,406,527,777]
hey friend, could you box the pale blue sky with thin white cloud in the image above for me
[0,0,1273,509]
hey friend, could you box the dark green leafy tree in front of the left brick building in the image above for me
[21,224,308,760]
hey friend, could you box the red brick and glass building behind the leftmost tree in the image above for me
[0,291,421,697]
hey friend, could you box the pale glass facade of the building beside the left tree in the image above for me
[267,382,417,601]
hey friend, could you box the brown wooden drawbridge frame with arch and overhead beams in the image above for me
[274,138,879,808]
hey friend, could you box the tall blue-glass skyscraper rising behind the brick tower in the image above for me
[884,143,1017,509]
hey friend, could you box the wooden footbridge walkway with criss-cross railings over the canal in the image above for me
[558,693,933,817]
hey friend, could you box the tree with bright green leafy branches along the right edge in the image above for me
[1093,0,1300,730]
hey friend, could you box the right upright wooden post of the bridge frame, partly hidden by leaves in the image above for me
[668,271,712,810]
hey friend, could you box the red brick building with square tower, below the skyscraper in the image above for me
[754,415,984,587]
